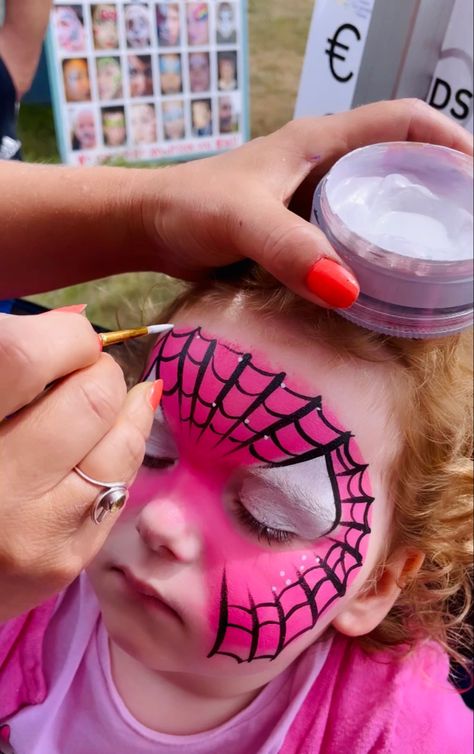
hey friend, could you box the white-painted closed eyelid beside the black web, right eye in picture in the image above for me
[238,456,338,539]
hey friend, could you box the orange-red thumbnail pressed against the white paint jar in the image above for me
[306,258,360,309]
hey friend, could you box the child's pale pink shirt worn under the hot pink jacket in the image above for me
[0,576,331,754]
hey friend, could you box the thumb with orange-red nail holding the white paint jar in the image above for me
[240,201,359,309]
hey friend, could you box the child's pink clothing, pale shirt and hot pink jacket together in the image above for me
[0,576,473,754]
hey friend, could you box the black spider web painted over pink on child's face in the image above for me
[146,328,373,663]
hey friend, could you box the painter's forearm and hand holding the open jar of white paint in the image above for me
[0,100,472,305]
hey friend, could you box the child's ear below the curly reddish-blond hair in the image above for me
[332,548,425,636]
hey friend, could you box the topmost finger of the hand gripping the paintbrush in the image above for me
[0,310,100,418]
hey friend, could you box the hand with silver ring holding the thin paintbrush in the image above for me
[0,310,156,621]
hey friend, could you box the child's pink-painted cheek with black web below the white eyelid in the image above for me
[205,490,370,662]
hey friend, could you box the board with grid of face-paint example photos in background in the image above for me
[50,0,245,164]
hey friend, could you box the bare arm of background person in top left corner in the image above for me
[0,0,52,99]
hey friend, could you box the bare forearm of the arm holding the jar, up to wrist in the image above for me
[0,161,162,298]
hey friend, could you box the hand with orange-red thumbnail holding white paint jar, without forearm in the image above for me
[143,100,472,306]
